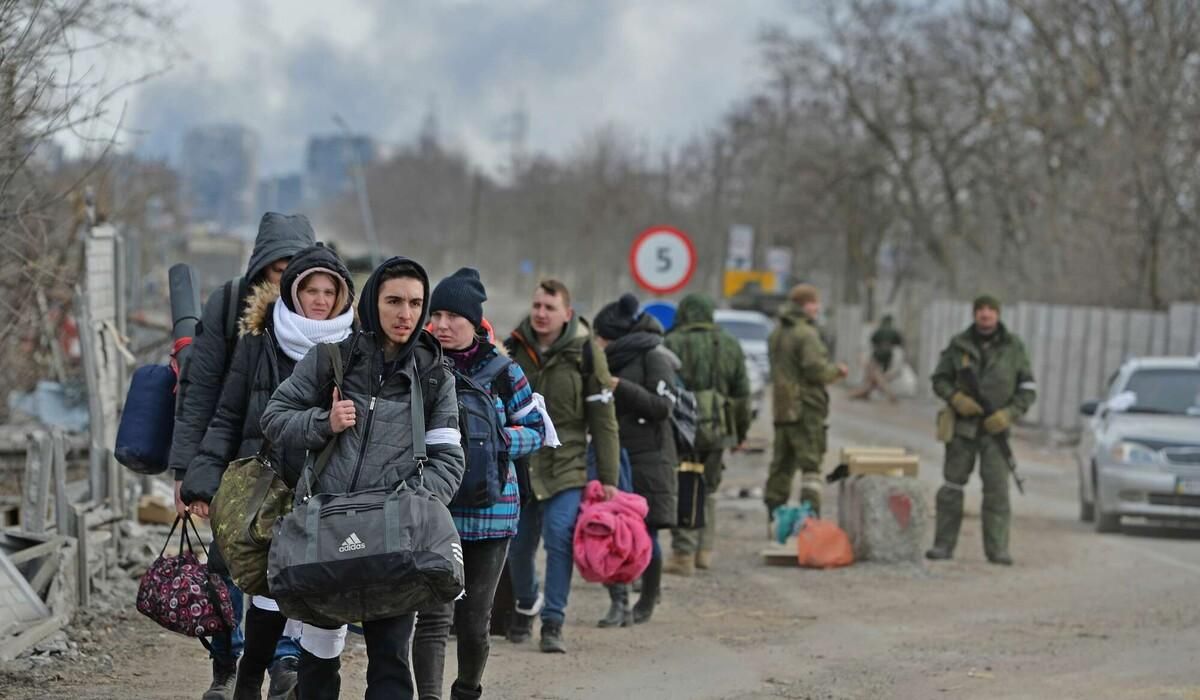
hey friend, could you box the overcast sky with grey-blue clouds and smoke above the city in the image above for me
[126,0,803,174]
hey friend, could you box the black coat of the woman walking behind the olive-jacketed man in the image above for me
[605,313,679,527]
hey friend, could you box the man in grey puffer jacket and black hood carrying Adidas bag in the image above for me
[262,258,466,700]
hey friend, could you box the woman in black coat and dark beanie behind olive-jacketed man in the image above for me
[593,294,679,627]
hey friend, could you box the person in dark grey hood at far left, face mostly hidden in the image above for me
[169,211,317,700]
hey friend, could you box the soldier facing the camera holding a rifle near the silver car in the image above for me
[925,295,1037,566]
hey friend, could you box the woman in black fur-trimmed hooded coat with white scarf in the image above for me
[180,244,354,698]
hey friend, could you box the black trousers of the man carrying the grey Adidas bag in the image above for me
[296,614,415,700]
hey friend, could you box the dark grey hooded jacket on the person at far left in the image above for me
[169,211,316,480]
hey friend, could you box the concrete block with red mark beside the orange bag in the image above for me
[838,474,929,563]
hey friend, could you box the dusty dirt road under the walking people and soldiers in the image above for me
[0,397,1200,700]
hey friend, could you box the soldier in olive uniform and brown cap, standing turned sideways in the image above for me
[763,285,848,521]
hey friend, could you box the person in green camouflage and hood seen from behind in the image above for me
[664,294,750,576]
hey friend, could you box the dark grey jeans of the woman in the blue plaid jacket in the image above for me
[413,538,509,700]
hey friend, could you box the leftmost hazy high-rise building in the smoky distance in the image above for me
[181,124,258,228]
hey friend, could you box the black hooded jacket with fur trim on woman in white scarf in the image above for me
[180,244,354,503]
